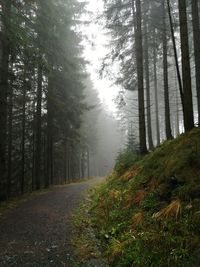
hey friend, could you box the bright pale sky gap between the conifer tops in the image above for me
[80,0,119,112]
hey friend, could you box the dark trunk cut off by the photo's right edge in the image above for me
[191,0,200,126]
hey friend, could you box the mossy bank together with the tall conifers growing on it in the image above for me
[72,0,200,267]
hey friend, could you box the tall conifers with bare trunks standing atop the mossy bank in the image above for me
[102,0,200,154]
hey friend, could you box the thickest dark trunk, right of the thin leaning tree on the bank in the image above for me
[178,0,194,131]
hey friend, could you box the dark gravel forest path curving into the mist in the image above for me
[0,178,102,267]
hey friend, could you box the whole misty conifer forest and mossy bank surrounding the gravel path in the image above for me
[0,0,200,267]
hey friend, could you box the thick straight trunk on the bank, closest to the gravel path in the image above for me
[135,0,147,154]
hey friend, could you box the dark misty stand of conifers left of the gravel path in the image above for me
[0,0,89,202]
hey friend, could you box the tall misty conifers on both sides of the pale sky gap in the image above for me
[0,0,200,199]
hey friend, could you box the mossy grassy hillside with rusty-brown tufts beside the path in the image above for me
[91,128,200,267]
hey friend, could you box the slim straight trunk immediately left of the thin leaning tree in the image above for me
[162,1,172,140]
